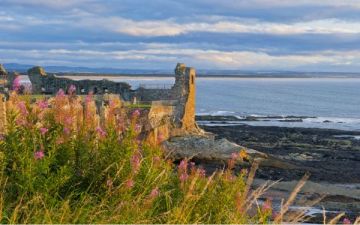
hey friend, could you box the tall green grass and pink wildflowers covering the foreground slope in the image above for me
[0,92,358,224]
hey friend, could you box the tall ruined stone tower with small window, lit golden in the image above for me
[172,63,198,132]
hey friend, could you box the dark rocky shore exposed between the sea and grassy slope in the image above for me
[191,116,360,222]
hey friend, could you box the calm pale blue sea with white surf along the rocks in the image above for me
[20,76,360,131]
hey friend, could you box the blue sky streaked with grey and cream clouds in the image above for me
[0,0,360,72]
